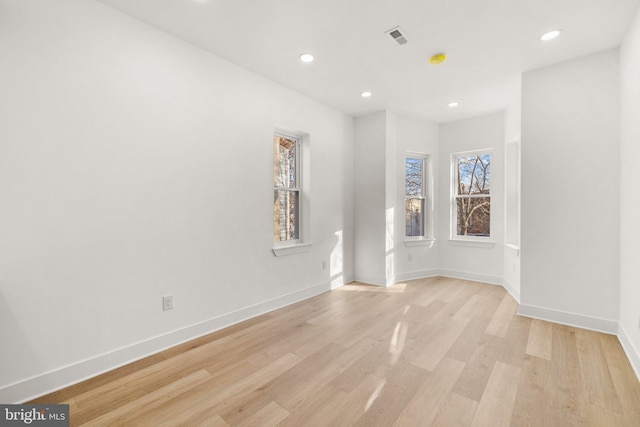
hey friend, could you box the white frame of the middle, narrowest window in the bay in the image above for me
[403,151,434,246]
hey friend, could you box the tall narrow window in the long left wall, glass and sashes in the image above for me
[273,135,300,242]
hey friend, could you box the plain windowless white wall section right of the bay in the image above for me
[520,50,620,332]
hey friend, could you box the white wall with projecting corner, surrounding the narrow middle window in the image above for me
[355,111,439,286]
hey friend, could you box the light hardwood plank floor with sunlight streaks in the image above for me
[32,277,640,427]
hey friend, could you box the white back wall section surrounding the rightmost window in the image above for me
[438,113,505,284]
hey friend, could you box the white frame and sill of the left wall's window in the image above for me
[271,128,311,256]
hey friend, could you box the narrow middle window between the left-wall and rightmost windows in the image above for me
[405,156,426,237]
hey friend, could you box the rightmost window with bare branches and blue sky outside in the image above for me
[452,151,491,239]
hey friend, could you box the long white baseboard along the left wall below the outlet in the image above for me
[0,282,335,403]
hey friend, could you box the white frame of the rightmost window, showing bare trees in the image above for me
[449,148,495,246]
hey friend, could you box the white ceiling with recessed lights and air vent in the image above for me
[100,0,639,122]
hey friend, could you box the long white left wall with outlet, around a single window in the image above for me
[0,0,353,402]
